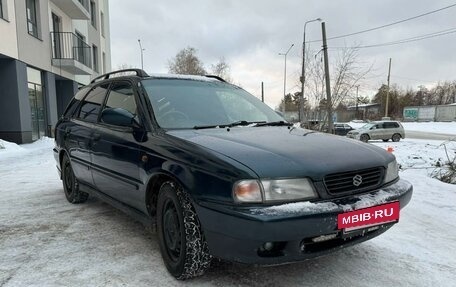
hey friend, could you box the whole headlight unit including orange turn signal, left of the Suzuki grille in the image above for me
[233,178,318,203]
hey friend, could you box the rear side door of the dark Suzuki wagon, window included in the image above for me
[63,84,108,185]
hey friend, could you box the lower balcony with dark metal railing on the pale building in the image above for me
[51,32,93,75]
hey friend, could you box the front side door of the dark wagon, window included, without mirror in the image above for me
[92,81,144,209]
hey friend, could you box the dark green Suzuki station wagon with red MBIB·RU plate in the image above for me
[54,69,413,279]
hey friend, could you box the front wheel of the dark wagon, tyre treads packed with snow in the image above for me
[157,181,211,280]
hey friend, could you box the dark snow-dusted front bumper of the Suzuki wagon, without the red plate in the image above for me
[195,180,413,265]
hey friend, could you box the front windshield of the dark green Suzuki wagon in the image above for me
[142,79,284,129]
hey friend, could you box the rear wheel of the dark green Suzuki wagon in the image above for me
[62,155,89,203]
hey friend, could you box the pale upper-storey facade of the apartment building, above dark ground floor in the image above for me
[0,0,111,84]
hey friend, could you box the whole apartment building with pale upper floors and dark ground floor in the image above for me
[0,0,111,143]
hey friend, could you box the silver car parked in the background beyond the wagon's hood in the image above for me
[347,121,405,142]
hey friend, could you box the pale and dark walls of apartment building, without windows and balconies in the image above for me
[0,0,111,143]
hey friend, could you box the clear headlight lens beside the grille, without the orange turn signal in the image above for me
[261,178,317,201]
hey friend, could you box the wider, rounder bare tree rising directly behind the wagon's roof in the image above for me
[168,47,206,75]
